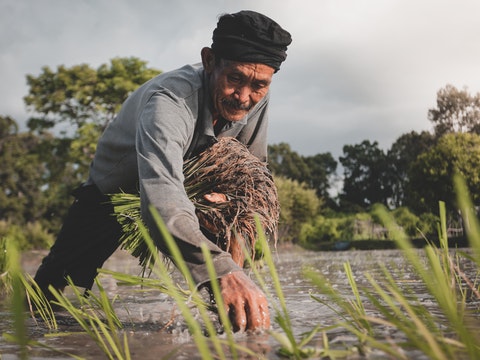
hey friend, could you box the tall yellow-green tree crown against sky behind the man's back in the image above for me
[24,57,160,131]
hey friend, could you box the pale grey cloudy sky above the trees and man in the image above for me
[0,0,480,158]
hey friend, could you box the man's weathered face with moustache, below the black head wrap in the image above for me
[207,60,274,121]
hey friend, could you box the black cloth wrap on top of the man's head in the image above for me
[212,11,292,72]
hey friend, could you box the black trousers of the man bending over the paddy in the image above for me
[35,185,121,298]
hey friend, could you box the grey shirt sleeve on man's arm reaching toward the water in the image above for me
[136,91,241,284]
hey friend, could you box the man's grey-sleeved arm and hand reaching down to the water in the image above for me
[137,91,270,331]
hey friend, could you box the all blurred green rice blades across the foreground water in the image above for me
[0,174,480,359]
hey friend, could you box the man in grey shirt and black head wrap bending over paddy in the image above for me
[35,11,291,331]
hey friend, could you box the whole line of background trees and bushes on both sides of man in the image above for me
[0,57,480,247]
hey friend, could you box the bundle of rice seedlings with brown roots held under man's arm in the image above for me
[111,138,280,268]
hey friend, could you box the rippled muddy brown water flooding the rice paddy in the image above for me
[0,248,478,360]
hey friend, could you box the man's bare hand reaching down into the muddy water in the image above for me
[220,271,270,331]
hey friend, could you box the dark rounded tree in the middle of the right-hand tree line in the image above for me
[339,140,392,210]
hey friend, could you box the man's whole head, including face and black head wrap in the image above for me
[202,11,292,121]
